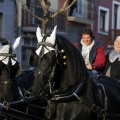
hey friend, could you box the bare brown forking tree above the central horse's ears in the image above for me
[19,0,77,34]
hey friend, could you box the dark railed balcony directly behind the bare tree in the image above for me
[22,7,66,32]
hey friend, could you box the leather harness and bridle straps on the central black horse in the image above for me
[36,41,120,120]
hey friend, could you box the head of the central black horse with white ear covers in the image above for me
[29,27,57,97]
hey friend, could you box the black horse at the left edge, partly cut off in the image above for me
[0,37,44,120]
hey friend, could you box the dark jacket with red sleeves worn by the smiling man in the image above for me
[79,42,106,71]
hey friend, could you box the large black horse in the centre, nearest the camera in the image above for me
[30,28,120,120]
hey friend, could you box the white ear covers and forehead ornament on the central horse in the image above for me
[36,26,57,55]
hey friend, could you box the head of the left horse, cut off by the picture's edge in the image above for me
[0,37,21,101]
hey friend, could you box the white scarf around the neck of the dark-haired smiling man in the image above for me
[81,40,95,64]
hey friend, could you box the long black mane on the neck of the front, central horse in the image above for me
[56,35,103,106]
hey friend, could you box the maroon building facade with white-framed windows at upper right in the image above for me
[93,0,120,50]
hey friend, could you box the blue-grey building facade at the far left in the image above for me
[0,0,17,43]
